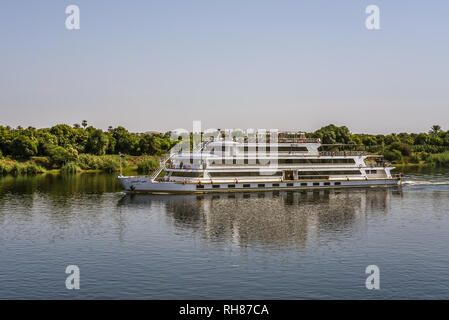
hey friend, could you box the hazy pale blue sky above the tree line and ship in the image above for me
[0,0,449,133]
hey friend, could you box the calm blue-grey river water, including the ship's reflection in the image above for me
[0,170,449,299]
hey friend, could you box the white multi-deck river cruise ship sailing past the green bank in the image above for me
[118,132,401,193]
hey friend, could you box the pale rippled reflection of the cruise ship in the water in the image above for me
[119,188,402,248]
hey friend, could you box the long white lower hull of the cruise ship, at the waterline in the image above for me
[118,176,401,193]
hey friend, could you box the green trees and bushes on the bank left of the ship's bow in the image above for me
[0,121,177,175]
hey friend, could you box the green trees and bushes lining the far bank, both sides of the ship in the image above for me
[0,120,449,175]
